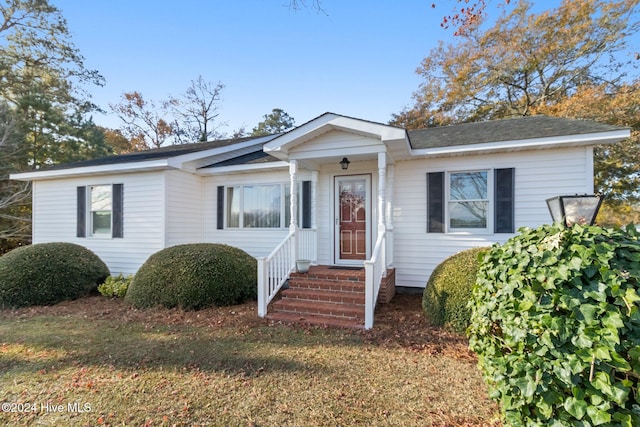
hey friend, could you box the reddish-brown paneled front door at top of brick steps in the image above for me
[336,176,369,261]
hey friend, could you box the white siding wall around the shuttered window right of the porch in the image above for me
[393,147,593,288]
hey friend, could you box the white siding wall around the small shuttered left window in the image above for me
[33,172,165,274]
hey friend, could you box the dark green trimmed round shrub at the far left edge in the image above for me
[0,242,109,307]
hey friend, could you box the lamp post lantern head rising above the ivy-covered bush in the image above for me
[547,194,602,227]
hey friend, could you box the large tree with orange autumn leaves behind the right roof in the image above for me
[392,0,638,127]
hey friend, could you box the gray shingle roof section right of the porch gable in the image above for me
[407,116,625,149]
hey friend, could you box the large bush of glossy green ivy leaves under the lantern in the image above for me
[469,225,640,427]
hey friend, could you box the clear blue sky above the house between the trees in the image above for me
[50,0,640,133]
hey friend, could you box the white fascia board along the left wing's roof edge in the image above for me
[9,159,170,181]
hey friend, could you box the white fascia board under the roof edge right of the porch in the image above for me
[411,129,631,156]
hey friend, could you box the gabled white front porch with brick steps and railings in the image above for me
[258,113,406,329]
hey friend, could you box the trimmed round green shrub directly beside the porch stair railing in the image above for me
[125,243,257,310]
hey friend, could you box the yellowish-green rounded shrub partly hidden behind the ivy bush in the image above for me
[422,247,488,333]
